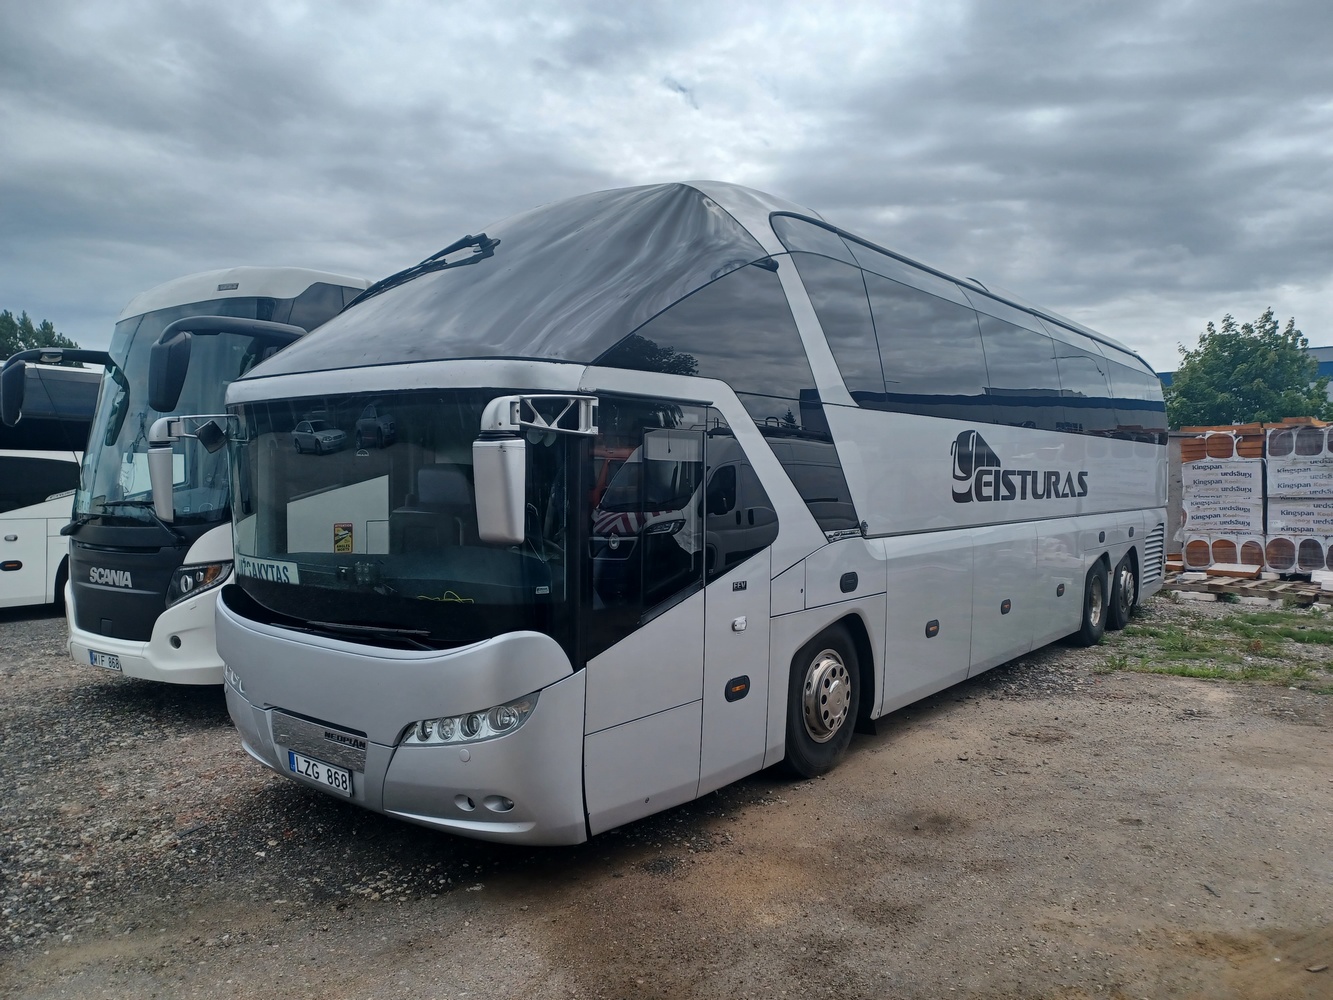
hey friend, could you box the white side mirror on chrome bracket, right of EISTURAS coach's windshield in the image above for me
[472,395,597,545]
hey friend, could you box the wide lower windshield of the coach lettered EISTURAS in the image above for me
[232,389,577,648]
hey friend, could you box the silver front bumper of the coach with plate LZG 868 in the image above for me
[217,604,588,844]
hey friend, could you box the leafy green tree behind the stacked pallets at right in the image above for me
[1164,309,1333,427]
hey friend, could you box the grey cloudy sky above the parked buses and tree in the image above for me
[0,0,1333,369]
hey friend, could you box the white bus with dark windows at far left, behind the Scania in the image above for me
[0,362,101,608]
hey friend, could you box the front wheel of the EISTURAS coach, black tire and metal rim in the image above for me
[785,625,861,777]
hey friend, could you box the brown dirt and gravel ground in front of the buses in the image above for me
[0,601,1333,1000]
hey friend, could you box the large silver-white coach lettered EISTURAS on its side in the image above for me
[159,183,1166,844]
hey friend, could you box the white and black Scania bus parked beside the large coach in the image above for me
[50,267,369,684]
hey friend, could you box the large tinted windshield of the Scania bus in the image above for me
[75,297,281,524]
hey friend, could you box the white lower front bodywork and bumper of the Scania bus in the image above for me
[65,523,233,684]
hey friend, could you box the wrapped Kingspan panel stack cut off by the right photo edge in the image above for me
[1265,425,1333,573]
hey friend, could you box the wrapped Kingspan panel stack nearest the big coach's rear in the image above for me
[1181,424,1265,569]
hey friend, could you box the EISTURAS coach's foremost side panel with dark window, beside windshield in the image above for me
[584,413,704,833]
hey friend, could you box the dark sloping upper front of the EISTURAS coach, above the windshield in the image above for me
[251,184,765,376]
